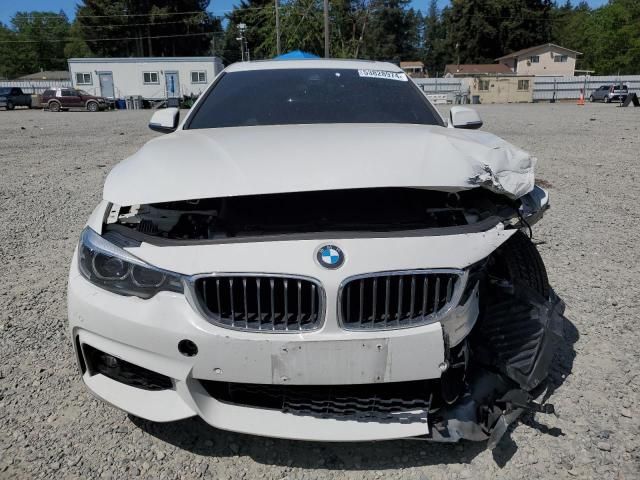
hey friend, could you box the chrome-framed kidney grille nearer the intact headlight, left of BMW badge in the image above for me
[195,275,324,332]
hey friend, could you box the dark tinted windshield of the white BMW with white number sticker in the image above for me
[186,68,442,129]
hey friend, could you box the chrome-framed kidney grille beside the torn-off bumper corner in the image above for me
[339,270,464,330]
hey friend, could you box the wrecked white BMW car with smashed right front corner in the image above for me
[68,60,563,445]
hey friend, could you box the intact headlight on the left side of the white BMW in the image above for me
[78,227,184,298]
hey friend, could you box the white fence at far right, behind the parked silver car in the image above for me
[533,75,640,102]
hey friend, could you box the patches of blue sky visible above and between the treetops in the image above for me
[0,0,607,24]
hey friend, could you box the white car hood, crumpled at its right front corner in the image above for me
[104,124,535,206]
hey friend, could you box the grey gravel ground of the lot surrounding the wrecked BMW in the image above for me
[0,104,640,480]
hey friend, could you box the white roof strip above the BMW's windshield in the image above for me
[225,59,404,73]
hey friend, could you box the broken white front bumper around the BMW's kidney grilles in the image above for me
[68,229,511,441]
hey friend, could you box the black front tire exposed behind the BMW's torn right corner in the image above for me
[491,231,551,298]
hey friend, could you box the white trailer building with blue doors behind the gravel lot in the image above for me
[68,57,224,100]
